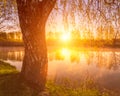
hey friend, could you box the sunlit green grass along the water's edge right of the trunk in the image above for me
[46,81,109,96]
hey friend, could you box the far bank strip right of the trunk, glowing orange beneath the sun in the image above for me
[47,39,120,48]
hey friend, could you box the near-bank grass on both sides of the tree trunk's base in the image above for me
[0,61,117,96]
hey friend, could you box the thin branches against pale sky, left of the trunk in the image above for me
[0,0,17,31]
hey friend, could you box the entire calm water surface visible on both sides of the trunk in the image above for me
[0,47,120,90]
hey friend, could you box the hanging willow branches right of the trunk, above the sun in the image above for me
[46,0,120,40]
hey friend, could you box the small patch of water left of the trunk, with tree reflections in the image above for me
[0,47,24,71]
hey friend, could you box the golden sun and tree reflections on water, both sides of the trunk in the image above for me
[0,48,120,70]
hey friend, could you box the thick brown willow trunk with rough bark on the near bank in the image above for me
[16,0,56,90]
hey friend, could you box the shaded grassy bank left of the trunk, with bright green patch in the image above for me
[0,61,37,96]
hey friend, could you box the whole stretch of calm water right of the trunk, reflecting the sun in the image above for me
[48,48,120,90]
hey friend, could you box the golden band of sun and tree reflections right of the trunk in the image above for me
[49,48,120,70]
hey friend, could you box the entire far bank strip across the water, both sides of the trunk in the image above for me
[0,39,120,48]
